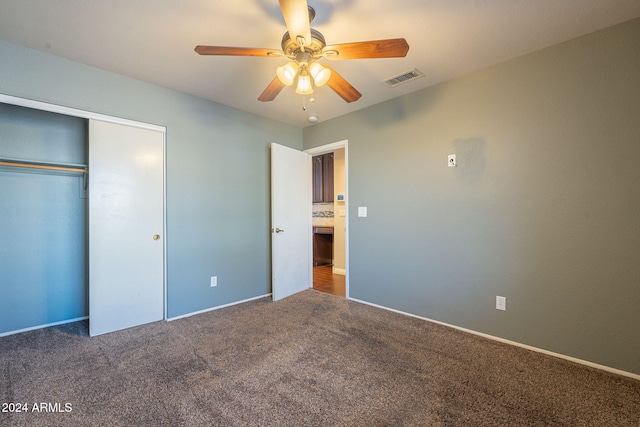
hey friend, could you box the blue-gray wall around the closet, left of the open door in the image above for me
[0,41,302,333]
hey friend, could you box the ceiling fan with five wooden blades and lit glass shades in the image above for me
[195,0,409,102]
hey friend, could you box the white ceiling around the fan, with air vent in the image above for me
[0,0,640,127]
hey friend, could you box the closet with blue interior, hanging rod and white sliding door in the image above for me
[0,95,165,336]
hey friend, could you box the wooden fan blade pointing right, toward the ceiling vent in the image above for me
[323,38,409,59]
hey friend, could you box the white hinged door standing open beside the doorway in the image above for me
[271,143,312,301]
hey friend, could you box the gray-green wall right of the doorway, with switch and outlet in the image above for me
[304,19,640,374]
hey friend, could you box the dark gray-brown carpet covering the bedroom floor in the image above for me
[0,290,640,426]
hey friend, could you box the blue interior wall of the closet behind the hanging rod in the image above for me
[0,103,88,335]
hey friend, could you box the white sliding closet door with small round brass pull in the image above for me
[89,120,164,336]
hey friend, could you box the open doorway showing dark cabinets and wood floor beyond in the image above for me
[305,140,349,298]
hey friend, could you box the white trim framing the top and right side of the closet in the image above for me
[0,93,168,321]
